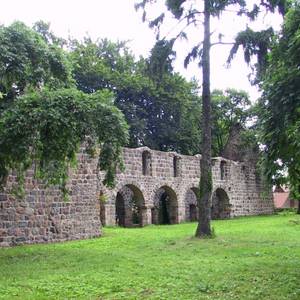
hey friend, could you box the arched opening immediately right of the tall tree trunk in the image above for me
[211,188,231,220]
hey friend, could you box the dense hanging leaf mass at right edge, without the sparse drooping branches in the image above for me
[260,5,300,199]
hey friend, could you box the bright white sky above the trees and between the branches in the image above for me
[0,0,281,101]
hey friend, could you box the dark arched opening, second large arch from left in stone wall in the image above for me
[151,186,178,224]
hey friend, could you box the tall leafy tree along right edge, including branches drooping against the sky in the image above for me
[229,0,300,213]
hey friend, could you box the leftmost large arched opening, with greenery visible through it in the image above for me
[116,185,145,227]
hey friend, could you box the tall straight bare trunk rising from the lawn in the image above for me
[196,0,212,237]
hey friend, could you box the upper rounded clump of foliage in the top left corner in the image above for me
[0,22,71,106]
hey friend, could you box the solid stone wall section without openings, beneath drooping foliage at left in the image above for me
[0,150,101,246]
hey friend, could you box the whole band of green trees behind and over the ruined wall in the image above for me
[0,21,255,197]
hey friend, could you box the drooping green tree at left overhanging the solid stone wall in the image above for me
[0,21,128,196]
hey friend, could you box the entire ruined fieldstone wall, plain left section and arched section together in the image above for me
[0,147,273,246]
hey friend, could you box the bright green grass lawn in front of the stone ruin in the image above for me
[0,214,300,300]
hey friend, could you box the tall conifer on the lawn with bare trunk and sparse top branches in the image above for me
[136,0,254,237]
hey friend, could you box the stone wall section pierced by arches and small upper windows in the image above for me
[100,147,274,225]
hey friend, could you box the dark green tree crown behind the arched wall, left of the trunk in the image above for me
[70,40,200,154]
